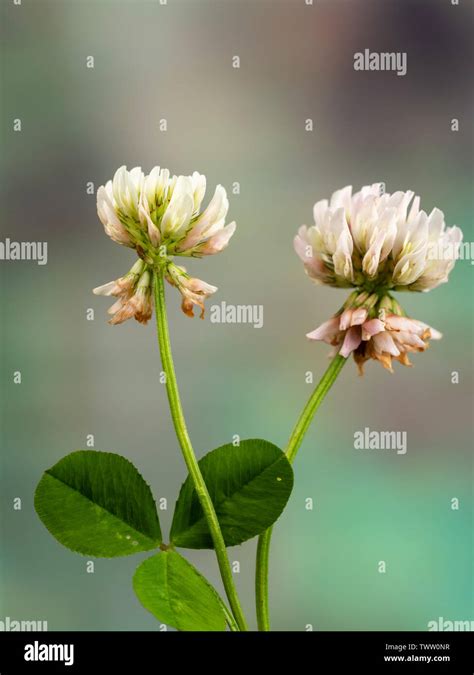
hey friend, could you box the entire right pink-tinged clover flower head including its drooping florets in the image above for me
[294,184,462,373]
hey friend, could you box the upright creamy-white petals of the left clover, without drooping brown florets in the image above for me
[97,166,236,265]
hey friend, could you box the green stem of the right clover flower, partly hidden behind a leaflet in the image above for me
[255,354,347,631]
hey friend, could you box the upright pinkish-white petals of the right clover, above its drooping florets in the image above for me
[294,183,462,292]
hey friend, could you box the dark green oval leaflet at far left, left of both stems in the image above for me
[35,450,162,558]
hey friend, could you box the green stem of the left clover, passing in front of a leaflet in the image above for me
[153,269,248,631]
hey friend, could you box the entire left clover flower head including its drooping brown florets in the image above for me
[94,166,236,323]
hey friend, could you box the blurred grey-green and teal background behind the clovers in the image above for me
[0,0,474,630]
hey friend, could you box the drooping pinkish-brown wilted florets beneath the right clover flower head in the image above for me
[307,292,442,374]
